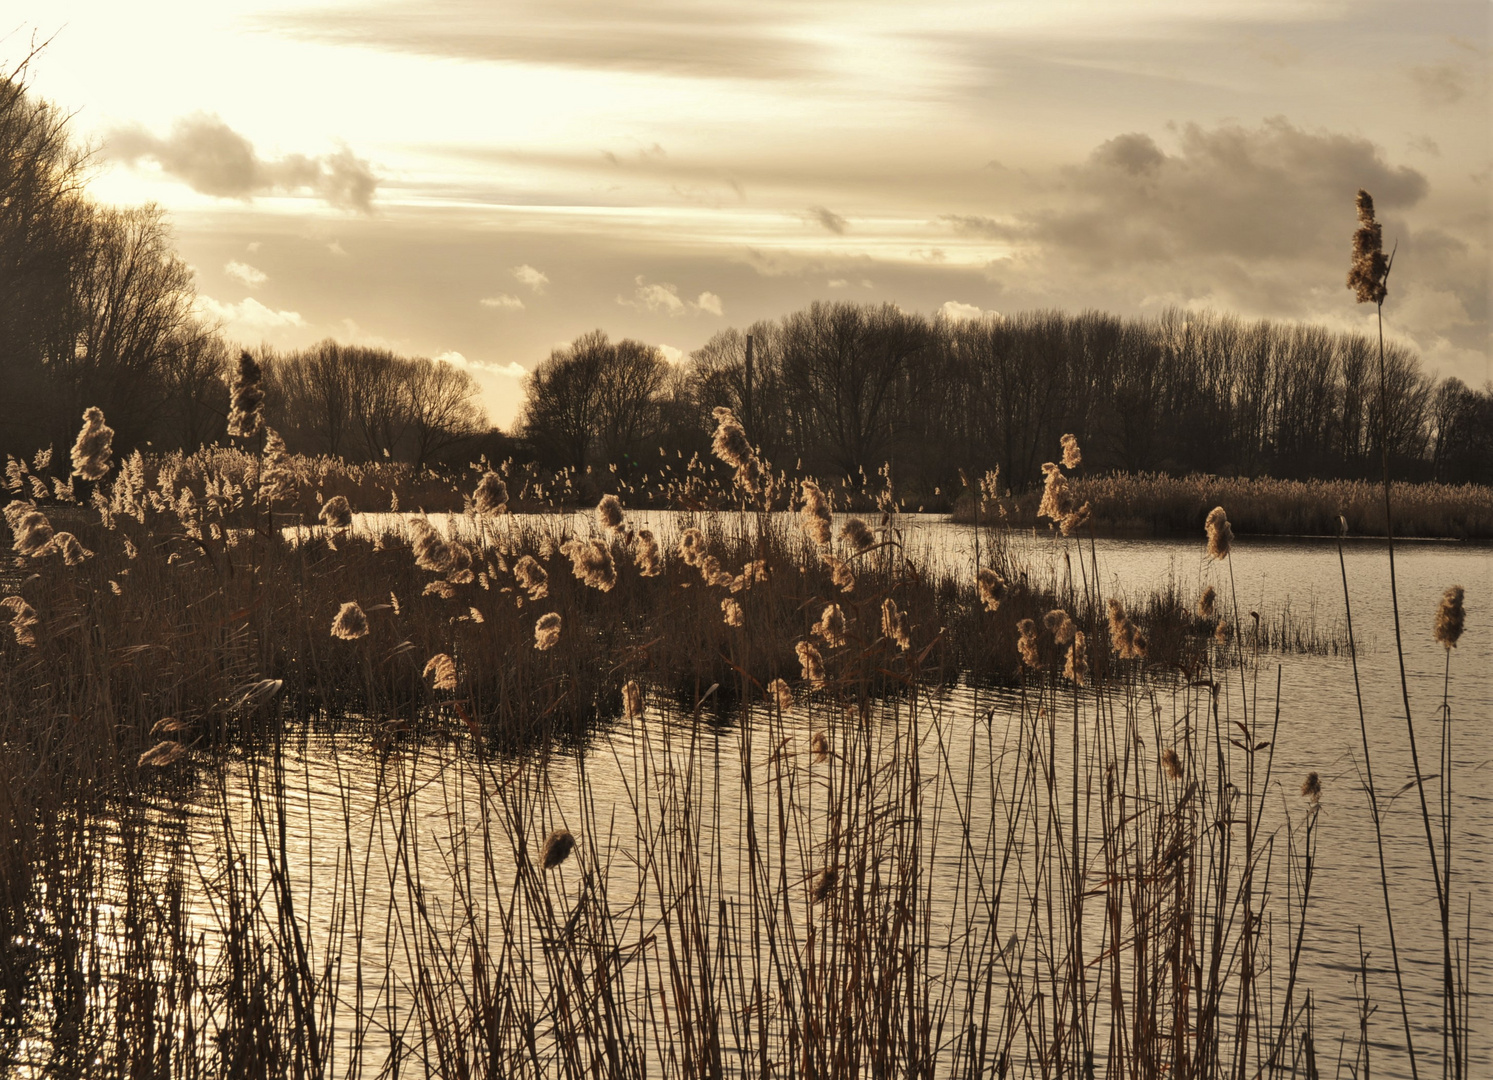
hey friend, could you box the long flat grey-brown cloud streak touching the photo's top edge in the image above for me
[273,0,815,79]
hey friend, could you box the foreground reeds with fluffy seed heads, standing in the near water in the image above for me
[0,409,1471,1077]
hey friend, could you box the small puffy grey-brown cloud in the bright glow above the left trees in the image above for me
[105,114,379,214]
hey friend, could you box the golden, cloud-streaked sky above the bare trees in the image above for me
[0,0,1493,426]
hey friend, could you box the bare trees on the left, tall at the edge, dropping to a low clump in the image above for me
[0,64,490,465]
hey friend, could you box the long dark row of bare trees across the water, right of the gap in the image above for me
[518,303,1493,494]
